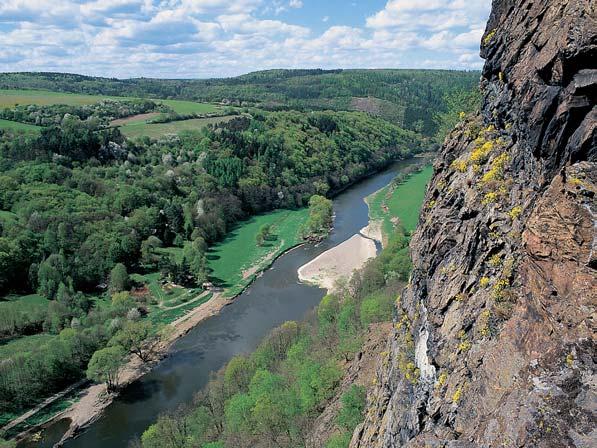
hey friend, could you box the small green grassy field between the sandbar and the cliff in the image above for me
[366,166,433,235]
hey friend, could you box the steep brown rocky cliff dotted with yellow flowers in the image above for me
[351,0,597,448]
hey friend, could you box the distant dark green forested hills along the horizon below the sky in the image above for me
[0,70,479,136]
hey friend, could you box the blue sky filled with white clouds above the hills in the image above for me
[0,0,491,78]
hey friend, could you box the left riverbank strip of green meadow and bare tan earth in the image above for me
[11,209,308,441]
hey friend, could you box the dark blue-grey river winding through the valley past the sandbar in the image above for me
[26,159,420,448]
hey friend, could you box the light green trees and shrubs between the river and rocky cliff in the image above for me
[137,169,431,448]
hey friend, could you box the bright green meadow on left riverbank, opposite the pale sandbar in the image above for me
[207,209,309,297]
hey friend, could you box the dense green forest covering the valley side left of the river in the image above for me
[0,70,474,440]
